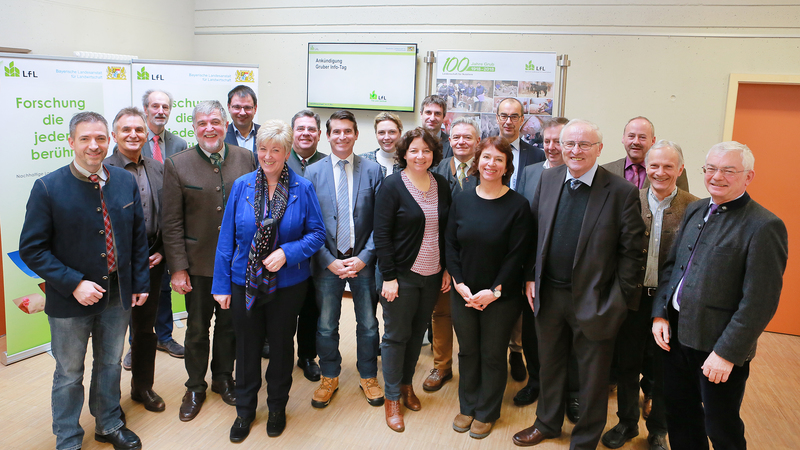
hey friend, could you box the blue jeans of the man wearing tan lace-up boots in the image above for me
[314,265,379,378]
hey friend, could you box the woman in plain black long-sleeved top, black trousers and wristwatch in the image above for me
[446,136,531,439]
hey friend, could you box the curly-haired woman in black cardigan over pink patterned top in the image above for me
[373,128,450,432]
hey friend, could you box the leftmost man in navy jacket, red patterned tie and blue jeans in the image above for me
[19,111,149,449]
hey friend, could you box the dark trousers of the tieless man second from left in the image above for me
[129,262,166,390]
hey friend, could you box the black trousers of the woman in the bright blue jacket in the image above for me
[231,281,308,419]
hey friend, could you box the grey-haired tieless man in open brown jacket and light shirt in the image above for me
[602,140,697,450]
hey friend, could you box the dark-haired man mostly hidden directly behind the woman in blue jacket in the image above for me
[286,109,326,381]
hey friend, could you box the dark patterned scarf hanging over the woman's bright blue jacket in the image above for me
[245,163,289,311]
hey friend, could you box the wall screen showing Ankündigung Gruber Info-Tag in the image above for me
[307,43,417,111]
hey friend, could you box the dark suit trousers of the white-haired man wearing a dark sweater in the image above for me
[534,280,614,450]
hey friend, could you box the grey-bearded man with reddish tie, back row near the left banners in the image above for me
[142,89,188,360]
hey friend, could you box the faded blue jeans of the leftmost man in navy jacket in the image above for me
[48,282,131,450]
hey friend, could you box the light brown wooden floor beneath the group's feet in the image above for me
[0,299,800,450]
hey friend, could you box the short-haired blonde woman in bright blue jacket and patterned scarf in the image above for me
[211,120,325,442]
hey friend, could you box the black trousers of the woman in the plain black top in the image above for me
[450,289,525,423]
